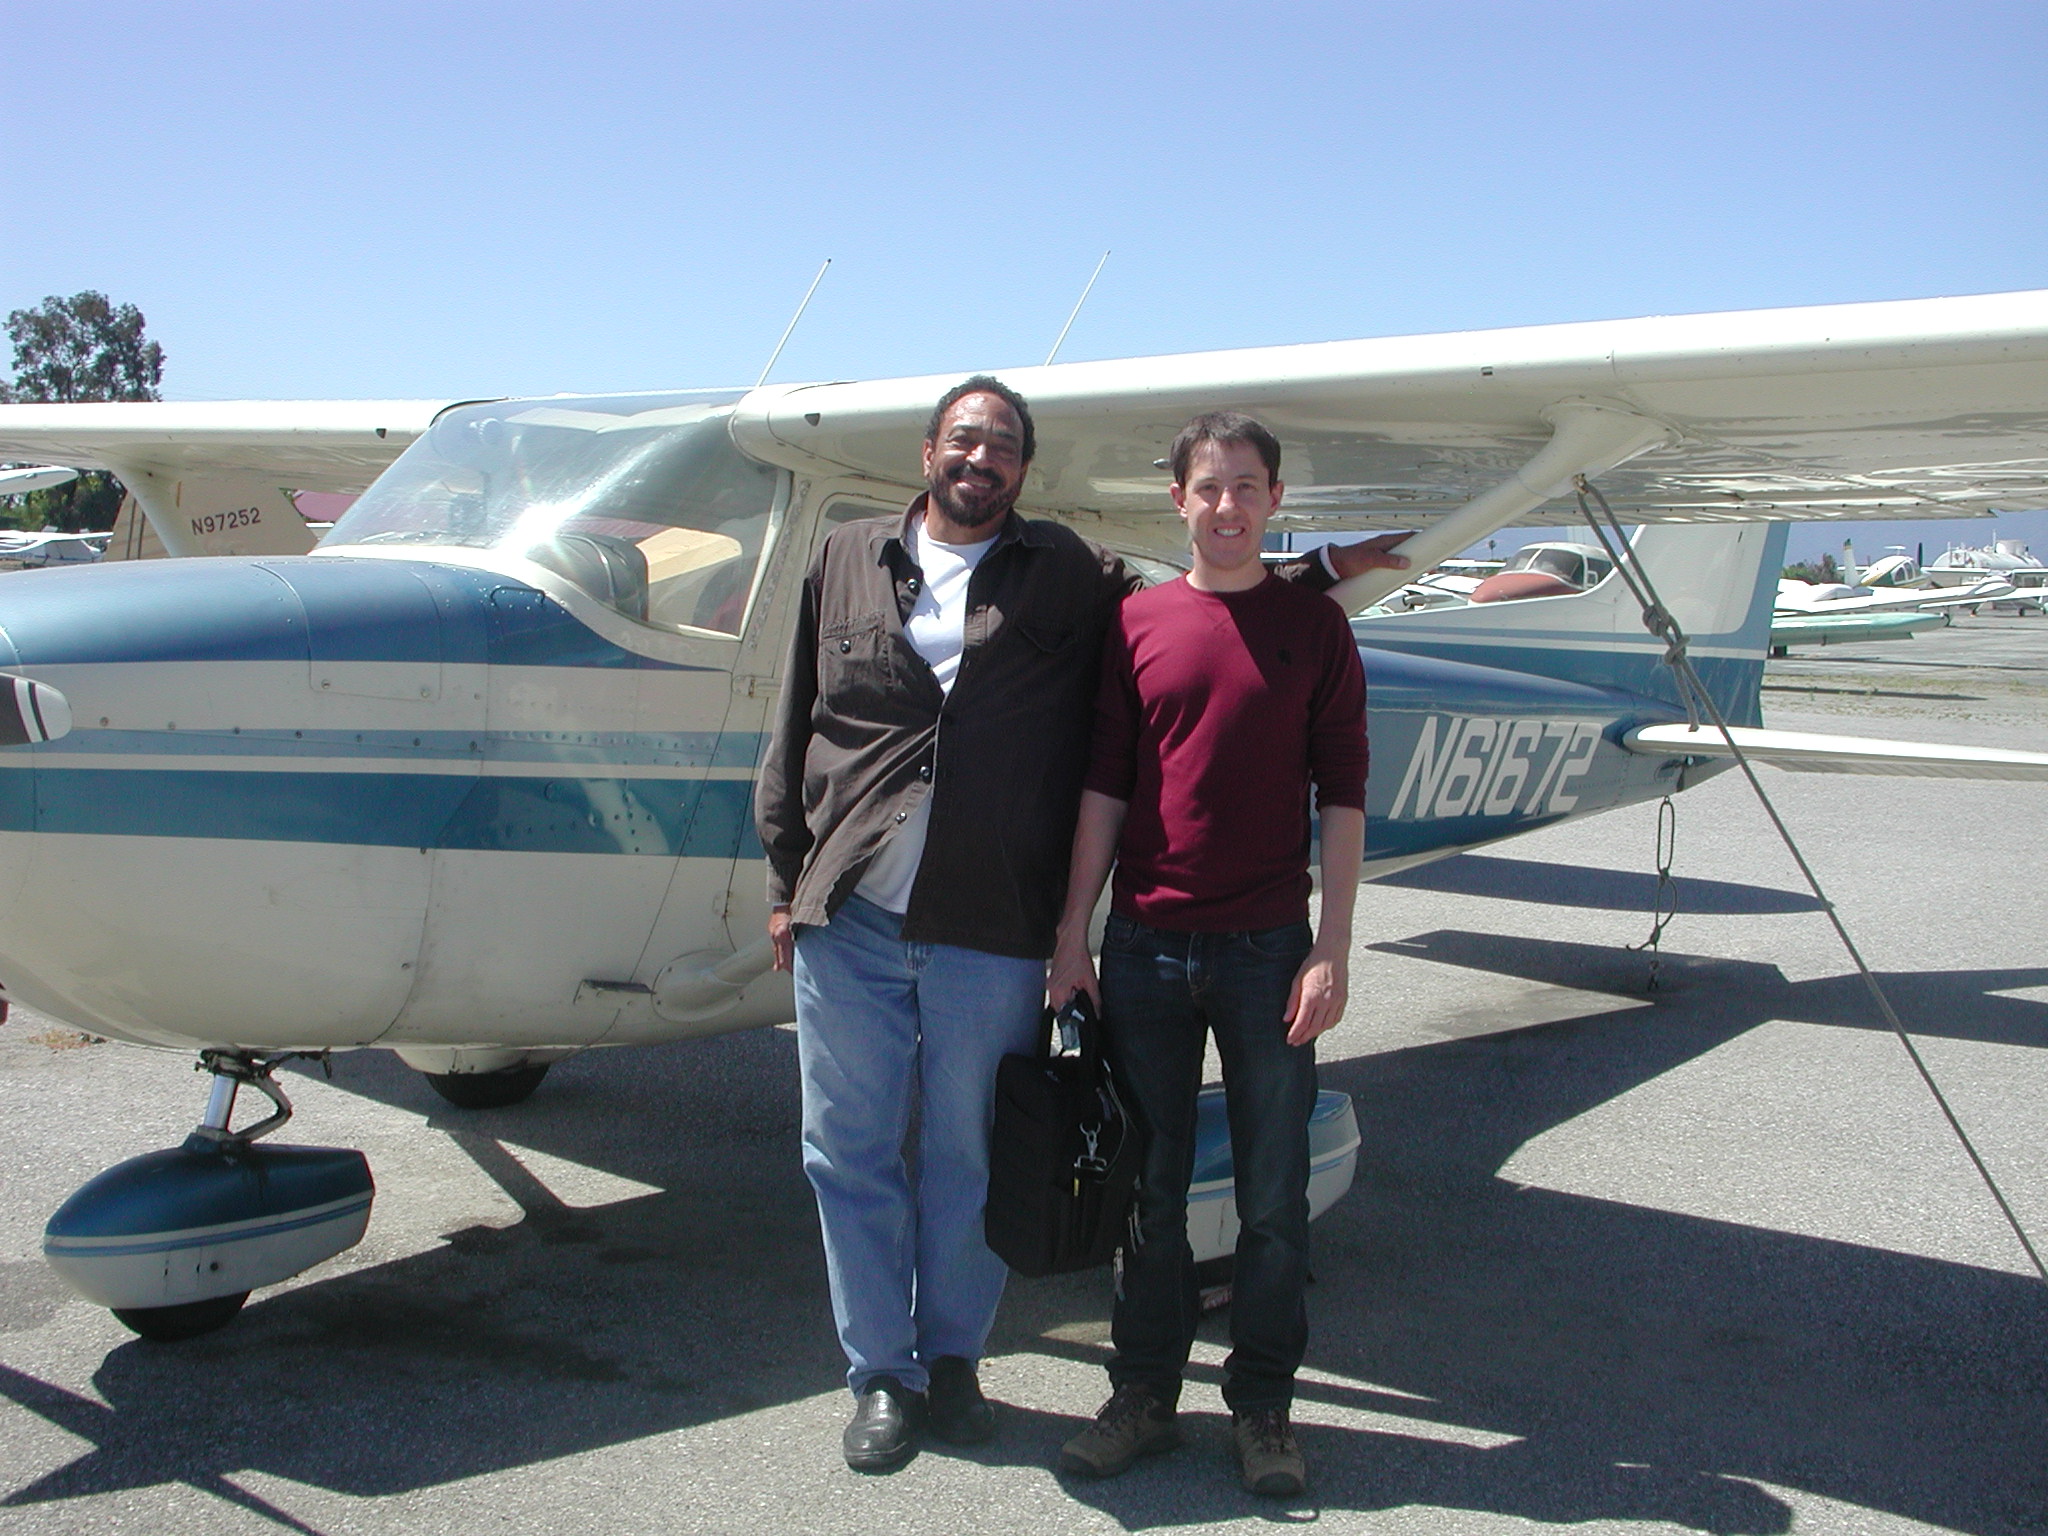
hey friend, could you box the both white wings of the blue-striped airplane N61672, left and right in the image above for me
[0,291,2048,569]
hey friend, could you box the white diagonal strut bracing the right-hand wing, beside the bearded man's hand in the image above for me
[1329,399,1677,612]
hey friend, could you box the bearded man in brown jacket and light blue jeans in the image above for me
[756,375,1407,1470]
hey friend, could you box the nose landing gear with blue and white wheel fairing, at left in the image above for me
[43,1051,375,1339]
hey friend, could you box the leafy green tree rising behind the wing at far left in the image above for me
[0,289,164,530]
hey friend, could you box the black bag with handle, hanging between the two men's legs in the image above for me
[983,991,1145,1276]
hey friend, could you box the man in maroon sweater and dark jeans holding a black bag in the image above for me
[1047,412,1366,1495]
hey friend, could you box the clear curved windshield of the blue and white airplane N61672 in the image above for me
[322,393,782,635]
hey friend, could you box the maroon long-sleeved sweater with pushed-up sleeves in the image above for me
[1087,578,1366,932]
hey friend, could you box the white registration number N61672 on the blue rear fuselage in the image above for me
[1389,715,1602,821]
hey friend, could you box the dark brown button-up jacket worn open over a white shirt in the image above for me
[754,496,1329,958]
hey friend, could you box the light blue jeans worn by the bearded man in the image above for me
[797,897,1044,1395]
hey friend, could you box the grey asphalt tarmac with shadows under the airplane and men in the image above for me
[0,618,2048,1536]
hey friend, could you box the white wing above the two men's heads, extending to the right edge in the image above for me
[733,291,2048,553]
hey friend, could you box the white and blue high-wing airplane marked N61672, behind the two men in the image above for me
[0,293,2048,1335]
